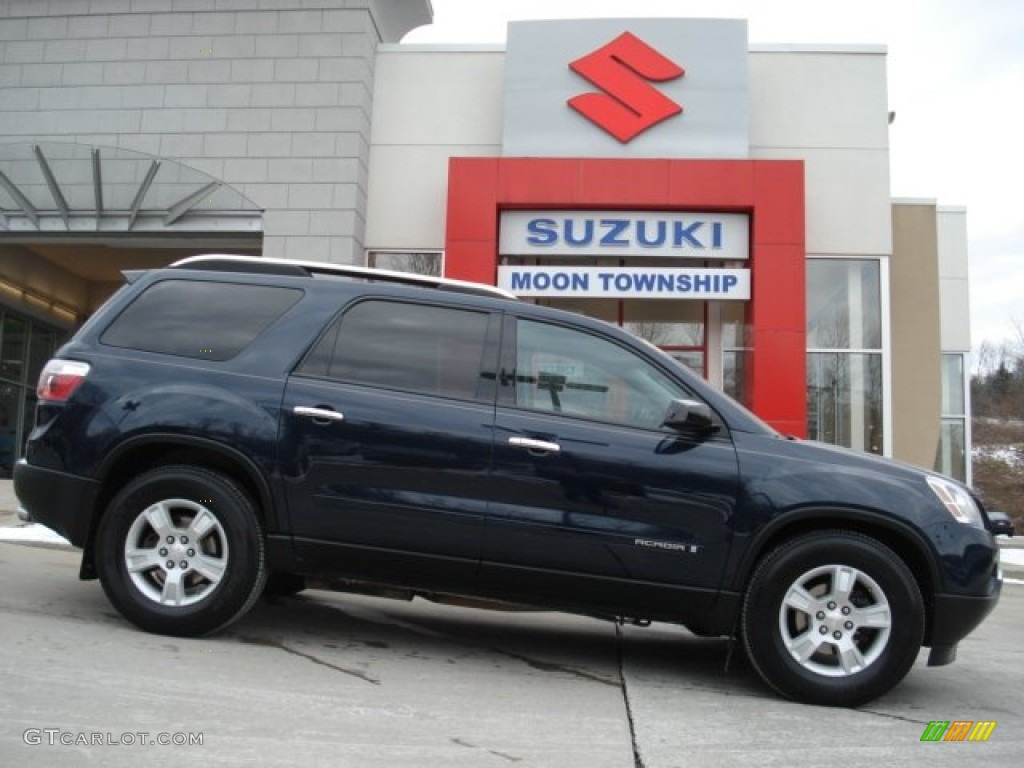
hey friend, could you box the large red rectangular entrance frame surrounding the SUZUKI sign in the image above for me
[444,158,807,436]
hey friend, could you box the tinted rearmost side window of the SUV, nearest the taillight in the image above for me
[99,280,302,360]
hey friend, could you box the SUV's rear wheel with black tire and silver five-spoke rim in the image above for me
[96,466,266,637]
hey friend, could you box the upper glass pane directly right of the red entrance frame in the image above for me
[807,259,882,349]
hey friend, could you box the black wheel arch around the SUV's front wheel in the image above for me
[733,508,940,645]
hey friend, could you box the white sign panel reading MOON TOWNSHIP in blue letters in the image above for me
[498,266,751,300]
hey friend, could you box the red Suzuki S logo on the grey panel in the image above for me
[568,32,685,144]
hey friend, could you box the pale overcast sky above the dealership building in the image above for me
[402,0,1024,348]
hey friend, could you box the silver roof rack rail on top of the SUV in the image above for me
[170,254,517,299]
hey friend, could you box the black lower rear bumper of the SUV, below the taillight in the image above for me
[14,459,99,547]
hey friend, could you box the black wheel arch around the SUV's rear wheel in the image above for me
[80,433,280,579]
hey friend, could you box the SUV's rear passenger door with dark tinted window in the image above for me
[281,299,500,585]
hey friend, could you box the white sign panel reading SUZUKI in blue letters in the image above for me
[498,211,751,259]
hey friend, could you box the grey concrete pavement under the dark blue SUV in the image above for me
[0,543,1024,768]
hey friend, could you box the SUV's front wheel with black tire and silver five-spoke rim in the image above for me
[740,530,925,707]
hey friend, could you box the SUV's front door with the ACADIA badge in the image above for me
[482,316,738,609]
